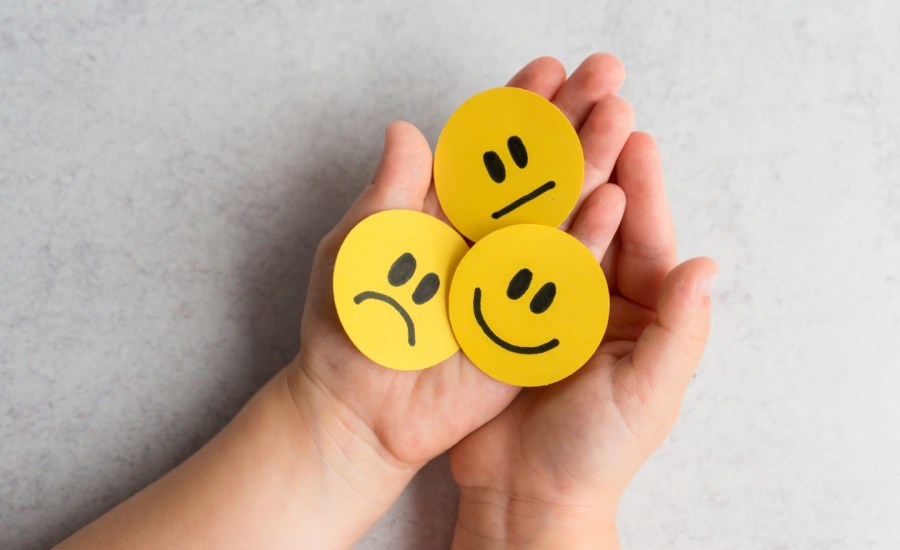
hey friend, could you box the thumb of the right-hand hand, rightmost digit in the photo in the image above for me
[631,258,718,403]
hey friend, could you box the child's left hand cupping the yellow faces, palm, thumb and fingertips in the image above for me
[288,55,632,540]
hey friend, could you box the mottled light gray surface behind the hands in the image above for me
[0,0,900,549]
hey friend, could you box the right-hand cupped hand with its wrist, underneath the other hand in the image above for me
[450,62,717,548]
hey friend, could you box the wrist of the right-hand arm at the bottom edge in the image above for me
[453,488,619,549]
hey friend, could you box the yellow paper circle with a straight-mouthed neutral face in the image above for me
[434,88,584,241]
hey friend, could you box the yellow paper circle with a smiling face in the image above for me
[450,224,609,386]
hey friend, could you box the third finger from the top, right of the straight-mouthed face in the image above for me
[560,96,634,231]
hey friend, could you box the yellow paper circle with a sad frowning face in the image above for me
[333,210,468,370]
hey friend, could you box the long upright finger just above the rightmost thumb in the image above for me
[615,132,677,308]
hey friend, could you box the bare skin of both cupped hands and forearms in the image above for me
[60,54,716,548]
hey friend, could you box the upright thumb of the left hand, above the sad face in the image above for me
[332,121,431,240]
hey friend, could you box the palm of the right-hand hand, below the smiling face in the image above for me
[451,278,665,502]
